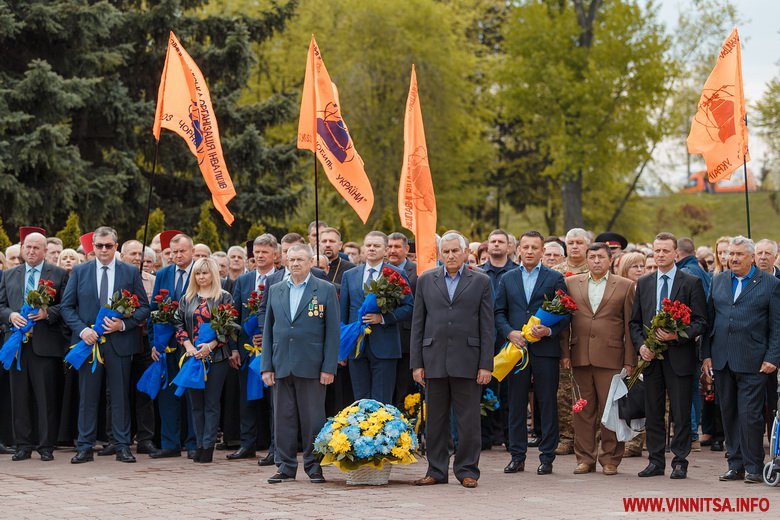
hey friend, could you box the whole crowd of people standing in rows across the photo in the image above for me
[0,222,780,488]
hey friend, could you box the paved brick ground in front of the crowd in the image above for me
[0,442,780,520]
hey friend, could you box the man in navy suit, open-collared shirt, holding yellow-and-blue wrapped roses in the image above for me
[496,231,569,475]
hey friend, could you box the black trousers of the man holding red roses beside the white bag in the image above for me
[643,360,693,470]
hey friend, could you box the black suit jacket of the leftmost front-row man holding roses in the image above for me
[0,262,68,357]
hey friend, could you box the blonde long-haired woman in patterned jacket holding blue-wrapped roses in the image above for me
[174,258,239,463]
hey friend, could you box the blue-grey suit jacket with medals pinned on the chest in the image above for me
[260,276,341,379]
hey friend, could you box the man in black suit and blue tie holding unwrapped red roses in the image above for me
[630,233,707,479]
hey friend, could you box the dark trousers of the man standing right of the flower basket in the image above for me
[425,377,482,482]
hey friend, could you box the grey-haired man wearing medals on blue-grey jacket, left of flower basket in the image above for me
[261,244,340,484]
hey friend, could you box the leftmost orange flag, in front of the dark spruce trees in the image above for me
[153,31,236,225]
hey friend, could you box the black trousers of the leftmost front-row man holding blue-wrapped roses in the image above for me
[9,346,62,449]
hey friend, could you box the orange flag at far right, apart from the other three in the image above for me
[688,27,750,183]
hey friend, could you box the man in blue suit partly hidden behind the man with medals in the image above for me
[227,233,277,460]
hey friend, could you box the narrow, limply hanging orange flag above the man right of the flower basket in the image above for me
[398,65,439,274]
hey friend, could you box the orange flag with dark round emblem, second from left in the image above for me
[298,35,374,224]
